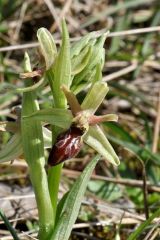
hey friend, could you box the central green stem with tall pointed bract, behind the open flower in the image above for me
[47,20,71,227]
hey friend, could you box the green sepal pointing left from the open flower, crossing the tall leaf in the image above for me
[23,108,73,129]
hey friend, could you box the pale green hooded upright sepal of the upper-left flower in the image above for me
[37,28,57,70]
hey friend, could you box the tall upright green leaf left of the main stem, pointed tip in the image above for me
[21,54,54,240]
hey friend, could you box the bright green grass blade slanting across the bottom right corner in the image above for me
[127,209,160,240]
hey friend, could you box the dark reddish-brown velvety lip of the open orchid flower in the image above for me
[48,125,83,166]
